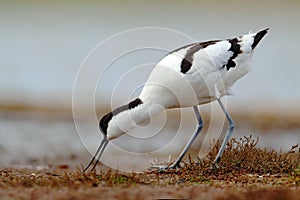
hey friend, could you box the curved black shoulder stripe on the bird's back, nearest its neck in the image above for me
[180,40,219,74]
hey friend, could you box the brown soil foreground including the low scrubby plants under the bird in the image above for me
[0,137,300,200]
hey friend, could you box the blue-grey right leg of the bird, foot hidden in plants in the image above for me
[213,99,234,164]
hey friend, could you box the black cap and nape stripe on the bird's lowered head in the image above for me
[99,98,143,135]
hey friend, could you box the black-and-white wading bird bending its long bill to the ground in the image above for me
[83,29,269,172]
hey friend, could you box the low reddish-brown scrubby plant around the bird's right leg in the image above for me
[201,135,299,174]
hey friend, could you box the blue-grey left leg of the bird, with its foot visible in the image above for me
[150,106,203,171]
